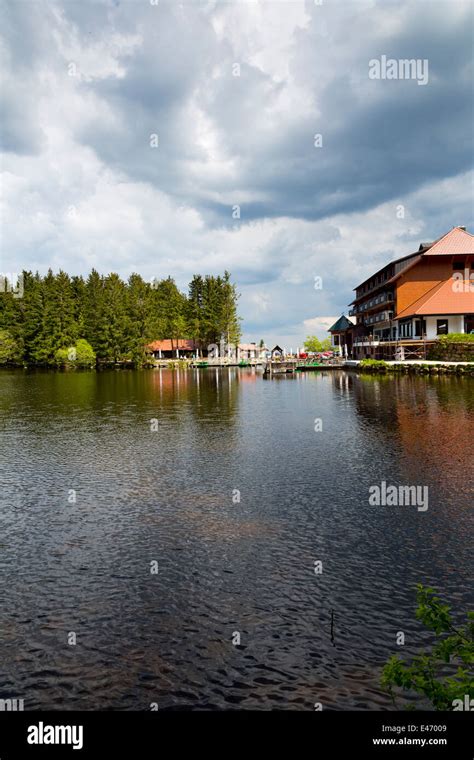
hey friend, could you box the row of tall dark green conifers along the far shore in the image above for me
[0,270,240,365]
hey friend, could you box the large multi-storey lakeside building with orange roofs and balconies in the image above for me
[331,227,474,359]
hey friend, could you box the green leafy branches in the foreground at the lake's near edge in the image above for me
[381,584,474,710]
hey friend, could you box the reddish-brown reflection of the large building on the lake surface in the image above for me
[348,372,472,502]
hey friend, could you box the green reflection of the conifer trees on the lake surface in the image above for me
[0,368,243,435]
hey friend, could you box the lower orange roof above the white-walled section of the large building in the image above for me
[396,279,474,319]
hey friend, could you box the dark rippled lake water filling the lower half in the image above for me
[0,369,474,710]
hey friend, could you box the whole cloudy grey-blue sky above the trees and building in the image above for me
[0,0,474,349]
